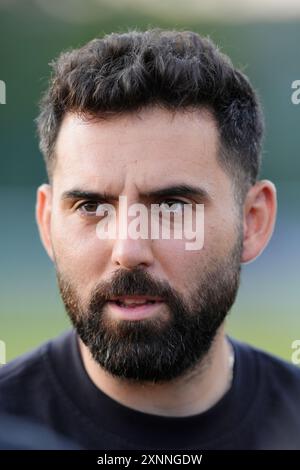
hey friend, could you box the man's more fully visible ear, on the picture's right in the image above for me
[241,180,277,263]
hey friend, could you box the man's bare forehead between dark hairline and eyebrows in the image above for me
[53,108,224,194]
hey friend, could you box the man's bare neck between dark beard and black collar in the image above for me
[79,326,232,417]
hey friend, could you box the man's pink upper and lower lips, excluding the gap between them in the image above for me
[107,296,164,321]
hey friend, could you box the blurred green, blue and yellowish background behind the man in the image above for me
[0,0,300,360]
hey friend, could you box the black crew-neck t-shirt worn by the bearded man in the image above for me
[0,331,300,450]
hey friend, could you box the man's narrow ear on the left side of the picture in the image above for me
[35,184,53,261]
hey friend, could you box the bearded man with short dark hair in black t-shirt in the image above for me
[0,30,300,450]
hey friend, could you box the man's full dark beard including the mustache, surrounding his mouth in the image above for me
[57,236,242,383]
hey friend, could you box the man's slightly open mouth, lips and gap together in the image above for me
[108,296,163,320]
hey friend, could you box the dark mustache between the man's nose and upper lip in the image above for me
[91,268,178,305]
